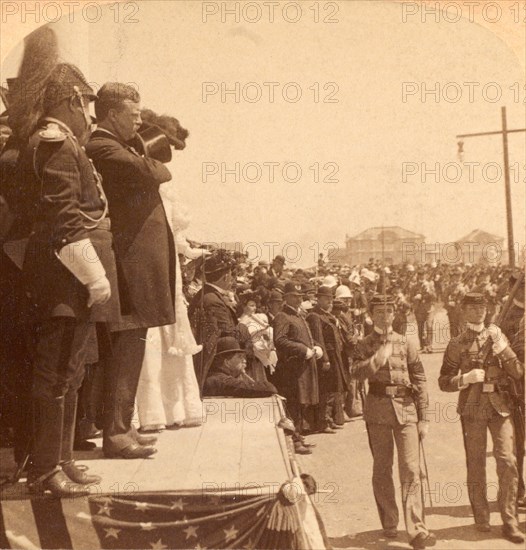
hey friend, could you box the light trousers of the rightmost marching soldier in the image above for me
[462,411,518,526]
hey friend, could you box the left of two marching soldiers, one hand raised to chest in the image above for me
[352,294,436,549]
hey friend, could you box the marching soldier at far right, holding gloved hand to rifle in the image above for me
[438,292,524,543]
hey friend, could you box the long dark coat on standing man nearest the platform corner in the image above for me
[274,304,319,405]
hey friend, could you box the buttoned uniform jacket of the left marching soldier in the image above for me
[352,330,429,424]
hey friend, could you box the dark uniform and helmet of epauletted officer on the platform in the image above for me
[21,64,119,487]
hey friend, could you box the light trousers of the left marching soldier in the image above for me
[367,419,428,540]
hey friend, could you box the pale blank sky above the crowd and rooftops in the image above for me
[0,0,526,265]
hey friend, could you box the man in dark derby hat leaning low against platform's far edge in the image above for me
[203,336,277,397]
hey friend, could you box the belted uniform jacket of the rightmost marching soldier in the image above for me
[438,328,524,419]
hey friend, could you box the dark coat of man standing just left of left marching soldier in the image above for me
[307,306,347,392]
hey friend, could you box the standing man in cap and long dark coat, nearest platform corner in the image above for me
[274,281,323,434]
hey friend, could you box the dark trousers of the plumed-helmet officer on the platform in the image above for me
[31,317,90,476]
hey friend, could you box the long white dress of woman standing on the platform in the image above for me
[136,197,209,432]
